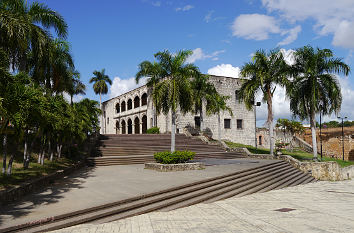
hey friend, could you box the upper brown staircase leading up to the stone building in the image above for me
[88,134,245,166]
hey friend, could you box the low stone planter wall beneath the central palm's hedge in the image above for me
[145,163,205,172]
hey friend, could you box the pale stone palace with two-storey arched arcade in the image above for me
[102,75,256,145]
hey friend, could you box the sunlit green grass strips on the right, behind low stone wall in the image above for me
[225,141,354,167]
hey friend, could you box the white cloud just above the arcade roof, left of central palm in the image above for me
[109,77,147,98]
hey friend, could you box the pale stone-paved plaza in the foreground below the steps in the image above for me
[56,180,354,233]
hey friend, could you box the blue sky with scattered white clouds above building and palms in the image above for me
[35,0,354,124]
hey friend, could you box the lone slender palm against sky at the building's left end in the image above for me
[90,69,112,133]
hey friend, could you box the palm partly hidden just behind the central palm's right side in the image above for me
[191,74,216,132]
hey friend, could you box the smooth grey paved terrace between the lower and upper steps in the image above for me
[0,159,275,231]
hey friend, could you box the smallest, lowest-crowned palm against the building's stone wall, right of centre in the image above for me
[206,92,233,143]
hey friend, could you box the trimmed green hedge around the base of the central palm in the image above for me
[154,150,195,164]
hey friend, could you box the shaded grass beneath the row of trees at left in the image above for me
[0,156,75,190]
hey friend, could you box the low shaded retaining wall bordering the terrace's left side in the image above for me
[0,162,85,204]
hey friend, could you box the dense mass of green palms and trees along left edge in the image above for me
[0,0,100,174]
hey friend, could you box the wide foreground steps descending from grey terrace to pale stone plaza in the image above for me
[0,160,315,232]
